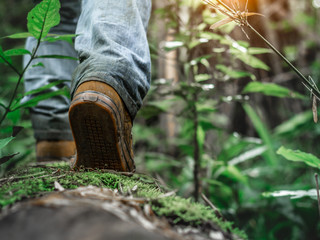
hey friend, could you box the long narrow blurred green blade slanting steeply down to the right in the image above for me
[242,103,277,166]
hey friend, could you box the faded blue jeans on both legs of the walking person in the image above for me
[24,0,151,140]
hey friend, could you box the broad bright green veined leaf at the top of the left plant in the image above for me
[27,0,60,39]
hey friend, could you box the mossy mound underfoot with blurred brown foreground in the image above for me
[0,162,247,240]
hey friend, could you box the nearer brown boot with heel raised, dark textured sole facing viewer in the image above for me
[69,81,135,172]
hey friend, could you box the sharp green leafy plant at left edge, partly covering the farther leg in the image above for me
[0,0,76,171]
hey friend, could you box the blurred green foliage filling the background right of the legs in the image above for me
[134,0,320,239]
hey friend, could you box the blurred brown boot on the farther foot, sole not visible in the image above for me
[36,140,76,162]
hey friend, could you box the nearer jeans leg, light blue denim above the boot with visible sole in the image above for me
[71,0,151,118]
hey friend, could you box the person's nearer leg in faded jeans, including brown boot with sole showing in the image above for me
[69,0,151,171]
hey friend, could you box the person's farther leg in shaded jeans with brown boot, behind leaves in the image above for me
[24,0,80,160]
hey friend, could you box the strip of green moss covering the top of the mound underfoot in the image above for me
[0,163,246,239]
